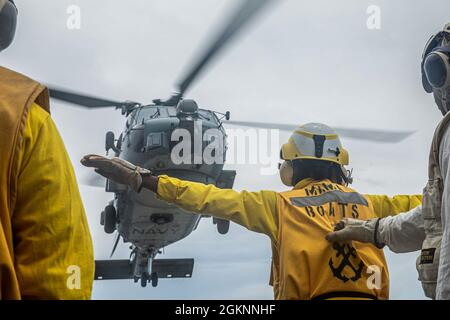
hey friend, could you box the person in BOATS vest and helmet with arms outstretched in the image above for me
[81,123,421,299]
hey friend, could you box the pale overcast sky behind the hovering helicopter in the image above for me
[0,0,450,299]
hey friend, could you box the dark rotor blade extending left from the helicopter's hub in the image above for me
[49,87,134,108]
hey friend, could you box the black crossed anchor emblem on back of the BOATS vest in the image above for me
[328,242,364,283]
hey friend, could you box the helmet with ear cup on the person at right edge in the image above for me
[422,31,450,93]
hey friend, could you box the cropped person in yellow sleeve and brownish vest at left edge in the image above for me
[0,0,94,299]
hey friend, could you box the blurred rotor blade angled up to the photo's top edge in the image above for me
[177,0,275,97]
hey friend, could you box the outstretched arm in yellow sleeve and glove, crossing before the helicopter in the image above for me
[81,155,278,241]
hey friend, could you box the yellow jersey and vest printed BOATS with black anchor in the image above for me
[157,175,421,299]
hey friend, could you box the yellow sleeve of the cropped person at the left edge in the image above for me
[13,104,94,299]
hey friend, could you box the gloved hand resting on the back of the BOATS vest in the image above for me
[326,218,384,249]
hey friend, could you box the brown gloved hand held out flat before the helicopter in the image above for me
[81,154,152,192]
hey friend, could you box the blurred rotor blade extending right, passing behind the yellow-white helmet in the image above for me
[224,121,414,143]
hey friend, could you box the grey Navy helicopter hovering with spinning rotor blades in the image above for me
[49,0,411,287]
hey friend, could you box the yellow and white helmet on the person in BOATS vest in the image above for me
[280,123,349,166]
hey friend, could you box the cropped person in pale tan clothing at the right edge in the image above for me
[328,23,450,300]
